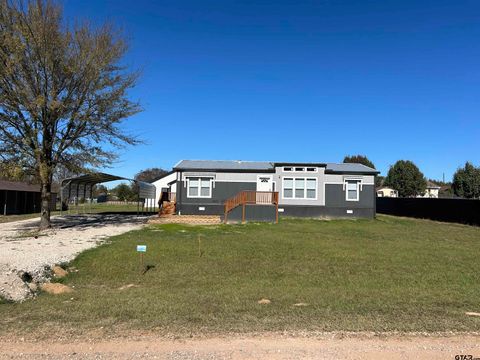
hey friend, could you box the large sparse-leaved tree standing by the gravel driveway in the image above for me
[0,0,141,228]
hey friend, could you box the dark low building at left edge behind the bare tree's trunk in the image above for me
[0,180,57,215]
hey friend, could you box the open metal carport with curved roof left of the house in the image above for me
[60,173,155,213]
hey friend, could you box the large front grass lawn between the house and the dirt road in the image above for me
[0,216,480,335]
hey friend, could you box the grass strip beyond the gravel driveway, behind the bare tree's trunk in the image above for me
[0,203,150,224]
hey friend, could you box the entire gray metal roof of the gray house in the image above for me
[174,160,379,175]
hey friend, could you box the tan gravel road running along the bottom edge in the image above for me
[0,335,480,360]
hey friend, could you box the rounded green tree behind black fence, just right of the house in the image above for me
[384,160,427,197]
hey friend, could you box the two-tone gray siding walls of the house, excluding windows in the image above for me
[177,167,375,221]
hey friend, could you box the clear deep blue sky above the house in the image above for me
[64,0,480,180]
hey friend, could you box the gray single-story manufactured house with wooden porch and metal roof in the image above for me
[162,160,378,220]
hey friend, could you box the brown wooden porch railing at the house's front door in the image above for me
[224,191,278,223]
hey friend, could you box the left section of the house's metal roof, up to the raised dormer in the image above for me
[174,160,274,171]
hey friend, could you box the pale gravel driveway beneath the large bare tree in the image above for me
[0,214,148,301]
